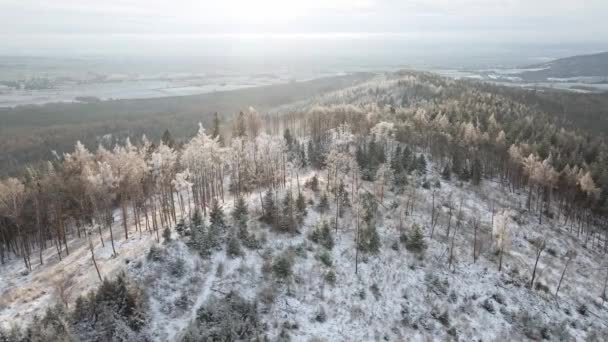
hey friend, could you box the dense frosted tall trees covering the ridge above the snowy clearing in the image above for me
[0,72,608,340]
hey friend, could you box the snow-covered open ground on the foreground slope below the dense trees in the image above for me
[0,164,608,341]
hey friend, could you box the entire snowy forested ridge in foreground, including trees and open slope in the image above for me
[0,71,608,341]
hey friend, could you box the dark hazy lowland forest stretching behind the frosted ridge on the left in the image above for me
[0,73,373,175]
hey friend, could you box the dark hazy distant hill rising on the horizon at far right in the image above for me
[520,52,608,81]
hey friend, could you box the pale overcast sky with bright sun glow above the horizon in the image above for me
[0,0,608,54]
